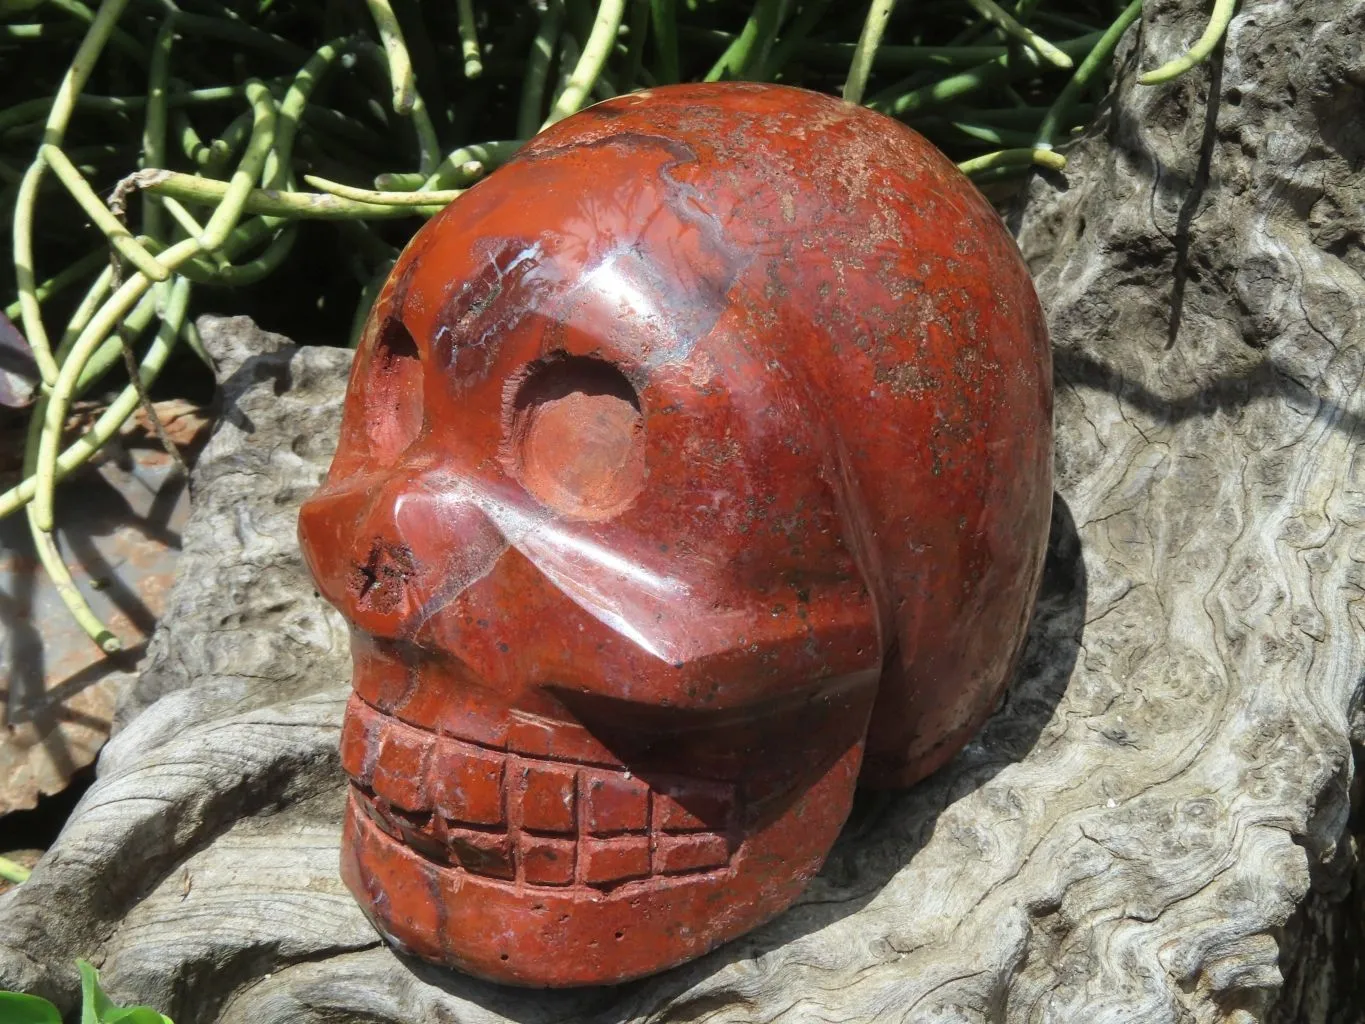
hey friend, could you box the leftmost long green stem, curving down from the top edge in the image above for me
[14,0,128,385]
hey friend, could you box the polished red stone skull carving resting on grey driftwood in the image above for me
[300,83,1051,986]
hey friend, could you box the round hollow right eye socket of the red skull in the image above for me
[508,356,644,520]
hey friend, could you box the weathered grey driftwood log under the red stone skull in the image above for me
[0,0,1365,1024]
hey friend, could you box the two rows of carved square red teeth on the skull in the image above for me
[341,696,737,887]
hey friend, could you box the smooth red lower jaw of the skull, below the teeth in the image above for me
[341,740,863,989]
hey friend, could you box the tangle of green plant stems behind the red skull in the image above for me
[0,0,1235,650]
